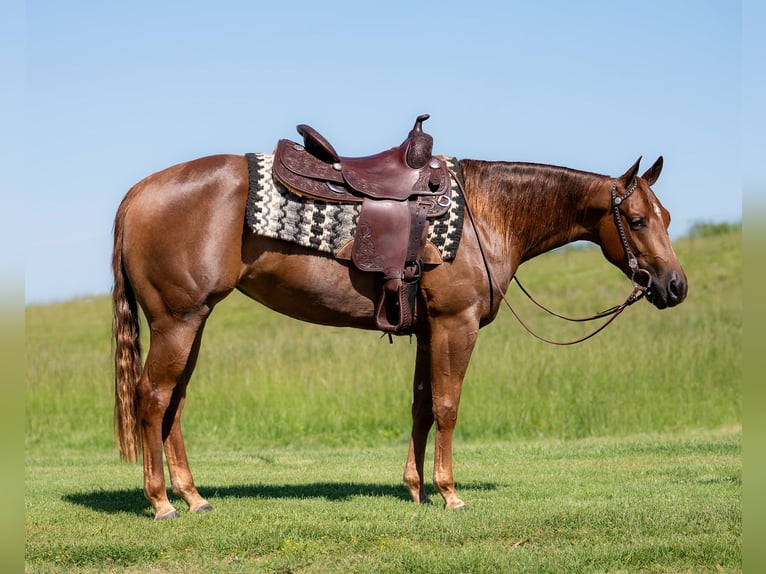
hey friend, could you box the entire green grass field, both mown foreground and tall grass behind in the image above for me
[25,229,743,572]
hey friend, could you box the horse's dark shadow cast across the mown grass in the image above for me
[62,482,497,516]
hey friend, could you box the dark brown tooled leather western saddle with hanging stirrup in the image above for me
[274,114,452,334]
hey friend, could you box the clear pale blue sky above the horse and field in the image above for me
[12,0,743,303]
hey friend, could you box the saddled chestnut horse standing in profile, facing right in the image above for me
[112,155,687,519]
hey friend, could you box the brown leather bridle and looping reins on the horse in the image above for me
[450,170,652,346]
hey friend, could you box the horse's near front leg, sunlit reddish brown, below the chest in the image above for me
[431,317,479,508]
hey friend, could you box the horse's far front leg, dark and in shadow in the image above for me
[404,336,434,504]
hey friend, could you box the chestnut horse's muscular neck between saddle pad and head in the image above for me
[461,160,607,263]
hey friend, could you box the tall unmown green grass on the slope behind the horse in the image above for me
[26,230,743,452]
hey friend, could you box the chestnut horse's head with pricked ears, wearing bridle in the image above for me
[597,156,687,309]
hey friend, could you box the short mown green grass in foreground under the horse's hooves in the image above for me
[26,430,741,573]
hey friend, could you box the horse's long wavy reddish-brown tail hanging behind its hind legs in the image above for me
[112,197,142,462]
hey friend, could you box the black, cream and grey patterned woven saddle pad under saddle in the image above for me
[245,153,465,261]
